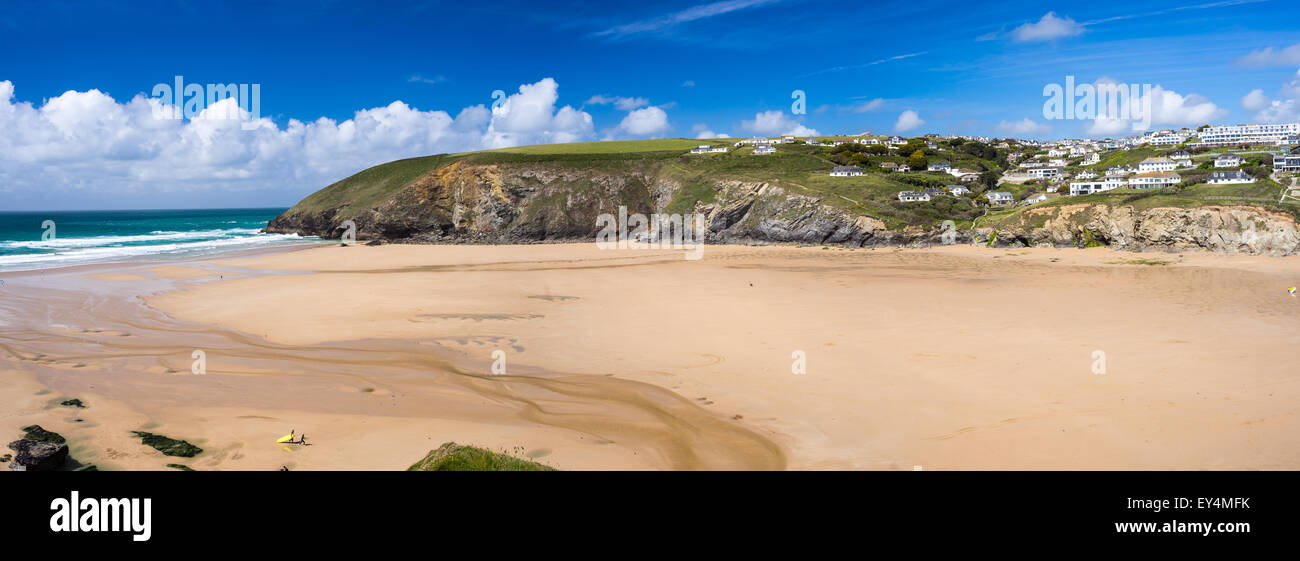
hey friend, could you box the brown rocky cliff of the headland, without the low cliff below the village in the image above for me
[267,157,925,247]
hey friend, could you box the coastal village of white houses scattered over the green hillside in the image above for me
[690,123,1300,219]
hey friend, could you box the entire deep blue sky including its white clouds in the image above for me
[0,0,1300,209]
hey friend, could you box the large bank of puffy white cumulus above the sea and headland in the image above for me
[0,78,594,205]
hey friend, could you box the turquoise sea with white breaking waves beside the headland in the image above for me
[0,208,321,271]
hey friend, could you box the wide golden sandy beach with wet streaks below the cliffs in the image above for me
[0,244,1300,470]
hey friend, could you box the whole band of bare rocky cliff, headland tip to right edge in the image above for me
[267,161,1300,255]
